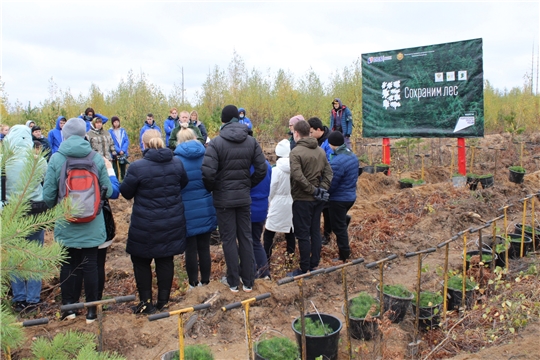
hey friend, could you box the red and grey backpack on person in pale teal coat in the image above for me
[58,150,101,223]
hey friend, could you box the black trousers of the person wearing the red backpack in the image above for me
[60,246,99,305]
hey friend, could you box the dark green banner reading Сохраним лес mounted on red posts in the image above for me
[362,39,484,138]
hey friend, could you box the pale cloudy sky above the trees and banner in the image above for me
[0,0,540,106]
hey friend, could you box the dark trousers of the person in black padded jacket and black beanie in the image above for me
[216,205,255,287]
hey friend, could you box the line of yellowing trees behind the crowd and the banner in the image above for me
[0,53,540,144]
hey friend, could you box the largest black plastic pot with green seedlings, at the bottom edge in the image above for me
[292,314,343,360]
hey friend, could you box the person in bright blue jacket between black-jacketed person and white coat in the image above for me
[250,160,272,279]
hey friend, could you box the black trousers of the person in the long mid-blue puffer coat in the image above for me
[186,232,212,286]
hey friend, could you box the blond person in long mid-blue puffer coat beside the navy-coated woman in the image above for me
[174,123,217,288]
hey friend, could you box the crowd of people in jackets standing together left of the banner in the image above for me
[6,99,358,322]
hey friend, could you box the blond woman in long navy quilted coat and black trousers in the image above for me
[120,130,188,314]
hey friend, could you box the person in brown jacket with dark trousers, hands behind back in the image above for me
[287,121,332,276]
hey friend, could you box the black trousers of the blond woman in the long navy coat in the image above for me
[130,255,174,301]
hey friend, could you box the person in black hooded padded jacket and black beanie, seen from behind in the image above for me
[202,105,267,292]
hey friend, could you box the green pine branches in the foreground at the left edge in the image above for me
[0,140,70,353]
